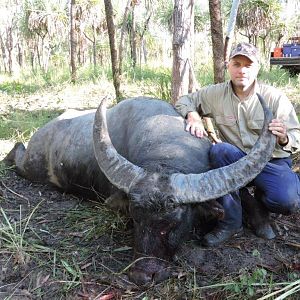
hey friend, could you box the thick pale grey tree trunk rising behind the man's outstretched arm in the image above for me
[171,0,194,103]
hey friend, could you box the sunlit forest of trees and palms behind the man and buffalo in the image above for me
[0,0,300,100]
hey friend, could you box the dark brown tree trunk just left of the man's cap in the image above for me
[209,0,225,83]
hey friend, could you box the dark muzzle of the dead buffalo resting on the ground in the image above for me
[128,257,172,286]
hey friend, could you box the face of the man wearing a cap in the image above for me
[228,55,259,90]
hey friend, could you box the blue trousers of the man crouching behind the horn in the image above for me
[210,143,300,228]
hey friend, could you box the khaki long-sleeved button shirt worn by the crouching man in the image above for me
[175,81,300,158]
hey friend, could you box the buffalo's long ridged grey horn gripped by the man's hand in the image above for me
[170,94,276,203]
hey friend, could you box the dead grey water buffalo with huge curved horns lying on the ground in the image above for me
[5,97,275,284]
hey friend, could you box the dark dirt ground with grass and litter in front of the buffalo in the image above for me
[0,165,300,300]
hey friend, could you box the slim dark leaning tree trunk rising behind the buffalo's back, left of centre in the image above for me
[104,0,122,102]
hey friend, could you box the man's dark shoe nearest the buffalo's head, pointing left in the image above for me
[202,226,243,247]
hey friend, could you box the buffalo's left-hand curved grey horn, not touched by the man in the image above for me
[93,98,146,193]
